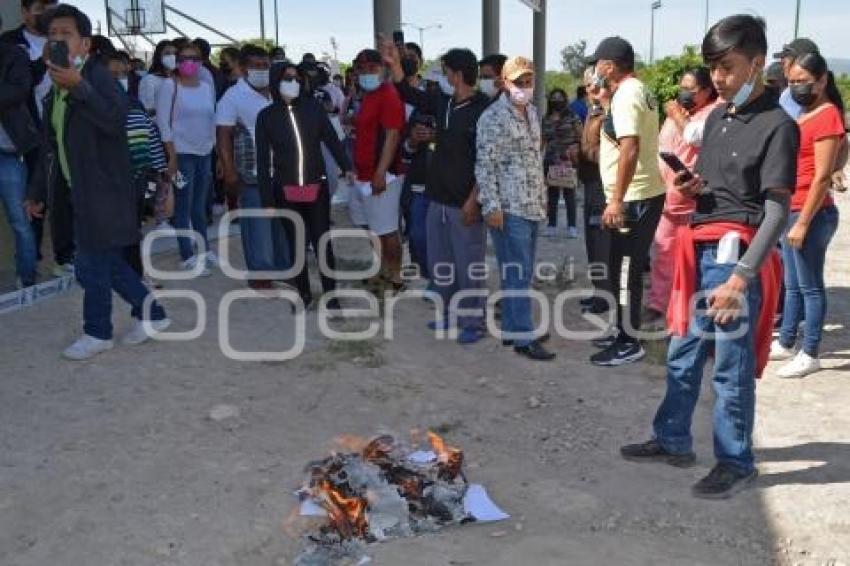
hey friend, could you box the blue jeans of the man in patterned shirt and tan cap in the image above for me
[490,213,537,347]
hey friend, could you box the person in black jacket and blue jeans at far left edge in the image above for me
[0,13,41,287]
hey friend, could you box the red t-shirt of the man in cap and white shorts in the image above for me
[354,82,405,181]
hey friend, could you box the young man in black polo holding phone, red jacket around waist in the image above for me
[621,15,800,499]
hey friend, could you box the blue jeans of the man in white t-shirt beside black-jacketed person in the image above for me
[239,185,290,271]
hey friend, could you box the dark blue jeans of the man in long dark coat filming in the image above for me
[74,248,165,340]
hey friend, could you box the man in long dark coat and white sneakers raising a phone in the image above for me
[27,4,169,360]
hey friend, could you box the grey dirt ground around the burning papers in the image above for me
[0,189,850,566]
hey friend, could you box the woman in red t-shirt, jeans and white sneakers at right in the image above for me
[771,53,846,377]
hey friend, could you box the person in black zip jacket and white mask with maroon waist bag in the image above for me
[256,63,354,309]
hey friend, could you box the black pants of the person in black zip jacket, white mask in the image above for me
[280,183,336,304]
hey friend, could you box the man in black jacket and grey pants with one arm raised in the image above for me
[383,42,489,344]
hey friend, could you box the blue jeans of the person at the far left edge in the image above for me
[0,153,38,285]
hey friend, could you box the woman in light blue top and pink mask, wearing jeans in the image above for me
[156,43,218,275]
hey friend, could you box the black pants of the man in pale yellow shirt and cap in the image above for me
[608,195,665,340]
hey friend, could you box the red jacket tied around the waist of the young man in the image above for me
[667,222,782,377]
